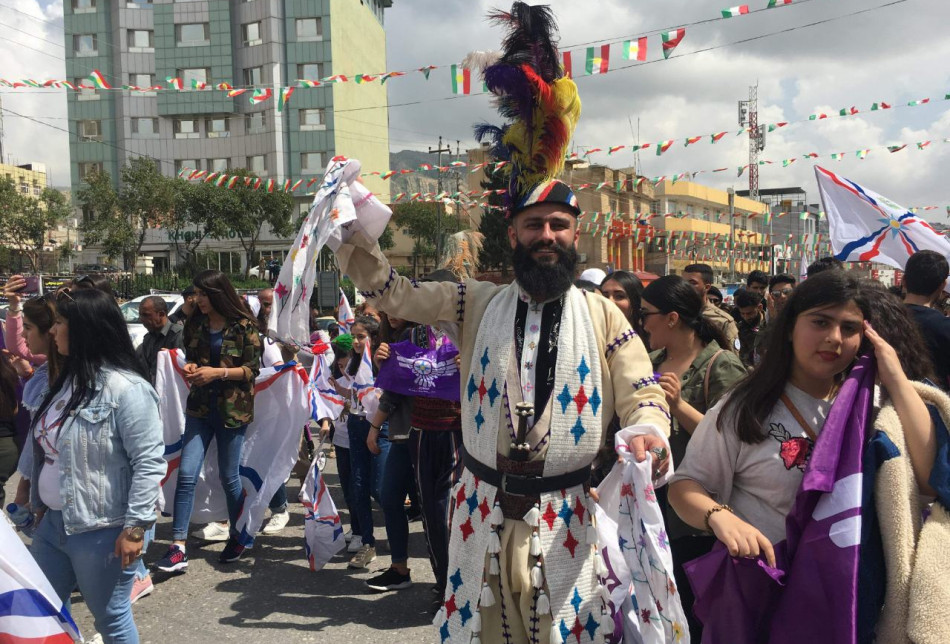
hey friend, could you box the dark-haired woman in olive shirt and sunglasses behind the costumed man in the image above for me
[640,275,746,641]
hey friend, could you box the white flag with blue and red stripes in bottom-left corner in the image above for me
[0,519,82,644]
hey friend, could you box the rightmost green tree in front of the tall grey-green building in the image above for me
[224,170,295,279]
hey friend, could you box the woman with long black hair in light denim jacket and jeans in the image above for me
[30,289,166,643]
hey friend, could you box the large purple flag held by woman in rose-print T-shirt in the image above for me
[685,356,875,644]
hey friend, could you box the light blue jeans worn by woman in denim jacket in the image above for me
[30,510,139,644]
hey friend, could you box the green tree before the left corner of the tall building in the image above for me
[77,158,175,270]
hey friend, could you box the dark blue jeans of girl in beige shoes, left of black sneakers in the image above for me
[346,414,389,546]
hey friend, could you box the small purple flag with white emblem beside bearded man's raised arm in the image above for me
[376,339,460,401]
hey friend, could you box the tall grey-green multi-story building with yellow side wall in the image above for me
[64,0,392,270]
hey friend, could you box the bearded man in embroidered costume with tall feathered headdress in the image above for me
[336,2,672,644]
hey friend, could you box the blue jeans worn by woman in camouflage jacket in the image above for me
[172,411,247,541]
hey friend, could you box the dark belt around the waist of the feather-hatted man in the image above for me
[461,447,591,520]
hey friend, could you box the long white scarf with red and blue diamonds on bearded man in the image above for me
[434,283,612,644]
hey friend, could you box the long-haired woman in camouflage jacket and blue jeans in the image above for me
[155,270,261,572]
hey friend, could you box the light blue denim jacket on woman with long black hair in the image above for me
[30,368,166,534]
